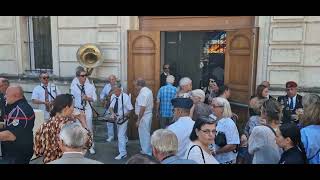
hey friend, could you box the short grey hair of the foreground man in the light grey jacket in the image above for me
[59,122,87,148]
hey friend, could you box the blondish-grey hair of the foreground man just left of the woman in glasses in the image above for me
[151,129,178,155]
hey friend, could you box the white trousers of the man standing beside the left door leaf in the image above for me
[138,113,152,155]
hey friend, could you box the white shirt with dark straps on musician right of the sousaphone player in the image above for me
[110,93,133,116]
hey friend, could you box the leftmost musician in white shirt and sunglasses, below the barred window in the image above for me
[31,71,61,121]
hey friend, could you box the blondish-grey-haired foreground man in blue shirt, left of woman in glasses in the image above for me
[151,129,196,164]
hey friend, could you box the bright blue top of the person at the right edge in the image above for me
[300,125,320,164]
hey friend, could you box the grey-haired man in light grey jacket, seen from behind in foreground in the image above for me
[48,123,103,164]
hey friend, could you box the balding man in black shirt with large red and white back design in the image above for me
[0,86,35,164]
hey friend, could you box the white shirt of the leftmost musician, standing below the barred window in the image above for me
[31,83,61,119]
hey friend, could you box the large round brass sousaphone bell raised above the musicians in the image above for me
[77,44,103,76]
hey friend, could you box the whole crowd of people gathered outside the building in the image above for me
[0,64,320,164]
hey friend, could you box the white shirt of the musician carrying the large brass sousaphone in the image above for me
[70,83,97,109]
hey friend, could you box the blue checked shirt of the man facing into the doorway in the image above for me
[157,83,177,117]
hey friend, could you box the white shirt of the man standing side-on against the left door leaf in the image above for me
[135,87,153,115]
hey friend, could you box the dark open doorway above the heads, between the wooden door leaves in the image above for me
[162,31,226,89]
